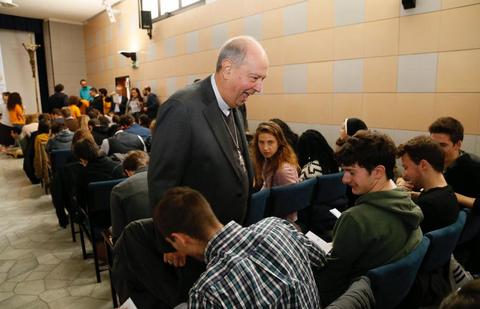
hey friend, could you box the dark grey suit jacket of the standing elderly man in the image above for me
[148,77,253,224]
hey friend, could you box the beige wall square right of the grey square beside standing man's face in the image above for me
[307,61,333,93]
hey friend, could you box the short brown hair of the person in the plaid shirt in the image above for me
[153,187,218,241]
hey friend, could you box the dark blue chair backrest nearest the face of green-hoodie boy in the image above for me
[313,172,347,208]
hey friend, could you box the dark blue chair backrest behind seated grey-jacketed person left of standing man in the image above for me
[87,178,125,227]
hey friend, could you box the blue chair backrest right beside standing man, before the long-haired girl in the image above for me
[268,178,317,218]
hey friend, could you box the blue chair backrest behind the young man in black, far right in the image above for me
[420,210,467,272]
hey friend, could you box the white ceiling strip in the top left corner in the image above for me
[0,0,122,23]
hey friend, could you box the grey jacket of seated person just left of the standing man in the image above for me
[110,168,151,240]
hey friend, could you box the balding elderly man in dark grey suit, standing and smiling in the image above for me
[148,36,268,295]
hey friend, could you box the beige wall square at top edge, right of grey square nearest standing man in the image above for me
[307,0,334,30]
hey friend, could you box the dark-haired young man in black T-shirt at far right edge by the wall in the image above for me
[428,117,480,273]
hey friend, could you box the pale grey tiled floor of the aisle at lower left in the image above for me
[0,154,112,309]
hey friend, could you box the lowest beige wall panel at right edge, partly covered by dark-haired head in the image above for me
[435,93,480,134]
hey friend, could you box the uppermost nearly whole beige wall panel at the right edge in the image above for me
[439,5,480,50]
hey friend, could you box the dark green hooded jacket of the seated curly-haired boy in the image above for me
[317,189,423,304]
